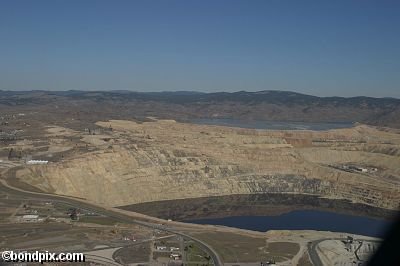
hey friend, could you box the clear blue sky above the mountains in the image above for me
[0,0,400,97]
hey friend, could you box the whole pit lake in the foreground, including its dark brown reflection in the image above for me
[120,193,396,237]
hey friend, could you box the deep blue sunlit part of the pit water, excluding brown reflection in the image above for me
[185,210,390,237]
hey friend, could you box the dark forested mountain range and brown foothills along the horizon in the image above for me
[0,90,400,127]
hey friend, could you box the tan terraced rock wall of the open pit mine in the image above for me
[17,121,400,209]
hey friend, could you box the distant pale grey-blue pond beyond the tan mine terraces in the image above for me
[190,118,354,131]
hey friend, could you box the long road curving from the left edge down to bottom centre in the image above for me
[0,179,223,266]
